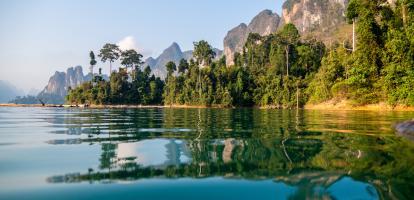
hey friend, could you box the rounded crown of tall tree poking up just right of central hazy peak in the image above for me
[193,40,216,66]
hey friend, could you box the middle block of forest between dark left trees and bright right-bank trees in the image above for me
[164,24,325,107]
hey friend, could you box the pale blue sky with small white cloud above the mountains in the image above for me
[0,0,283,92]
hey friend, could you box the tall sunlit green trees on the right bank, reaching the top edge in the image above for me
[308,0,414,106]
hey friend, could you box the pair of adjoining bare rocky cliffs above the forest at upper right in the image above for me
[224,0,350,65]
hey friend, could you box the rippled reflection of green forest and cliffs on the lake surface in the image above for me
[40,109,414,199]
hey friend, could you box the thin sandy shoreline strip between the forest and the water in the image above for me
[0,102,414,112]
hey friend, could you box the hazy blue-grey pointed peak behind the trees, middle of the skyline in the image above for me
[144,42,223,79]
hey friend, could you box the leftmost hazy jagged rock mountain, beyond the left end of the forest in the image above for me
[38,66,92,104]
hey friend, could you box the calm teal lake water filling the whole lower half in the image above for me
[0,108,414,200]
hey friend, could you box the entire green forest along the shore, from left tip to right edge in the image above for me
[66,0,414,108]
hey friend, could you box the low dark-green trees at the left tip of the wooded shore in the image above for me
[66,59,164,105]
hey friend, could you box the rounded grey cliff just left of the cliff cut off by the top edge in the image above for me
[224,10,280,65]
